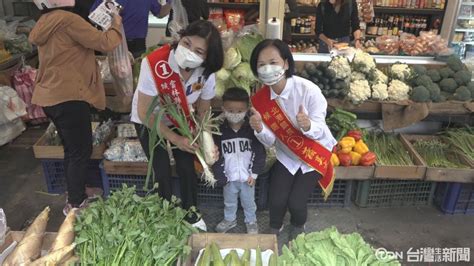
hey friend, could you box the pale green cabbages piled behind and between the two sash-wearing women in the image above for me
[216,30,263,97]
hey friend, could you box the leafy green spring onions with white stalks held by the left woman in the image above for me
[145,96,219,187]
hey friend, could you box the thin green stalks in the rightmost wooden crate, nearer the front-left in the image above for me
[413,139,467,168]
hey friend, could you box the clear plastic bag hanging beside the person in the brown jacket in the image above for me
[107,26,133,96]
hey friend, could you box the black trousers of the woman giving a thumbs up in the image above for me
[269,161,321,229]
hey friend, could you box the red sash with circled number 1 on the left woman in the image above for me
[147,45,194,128]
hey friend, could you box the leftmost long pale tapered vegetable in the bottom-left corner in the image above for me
[3,207,49,266]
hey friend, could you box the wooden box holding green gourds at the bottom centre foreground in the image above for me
[178,233,278,266]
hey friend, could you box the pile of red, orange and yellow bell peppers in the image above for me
[331,129,377,166]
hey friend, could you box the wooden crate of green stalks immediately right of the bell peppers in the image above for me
[374,136,426,180]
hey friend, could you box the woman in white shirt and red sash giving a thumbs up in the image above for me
[250,40,336,240]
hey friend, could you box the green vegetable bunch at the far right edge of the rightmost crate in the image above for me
[443,129,474,161]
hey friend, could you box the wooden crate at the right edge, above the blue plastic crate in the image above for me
[402,135,474,183]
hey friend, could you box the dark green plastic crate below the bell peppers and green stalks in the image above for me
[354,180,436,208]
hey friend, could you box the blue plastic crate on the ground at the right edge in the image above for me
[435,183,474,214]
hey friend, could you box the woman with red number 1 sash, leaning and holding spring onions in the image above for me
[131,20,224,231]
